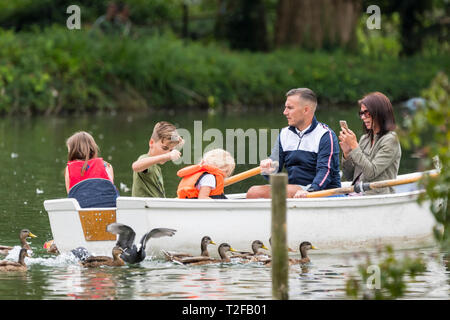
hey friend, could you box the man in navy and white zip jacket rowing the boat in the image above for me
[247,88,341,198]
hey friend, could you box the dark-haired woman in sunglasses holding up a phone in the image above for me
[339,92,402,194]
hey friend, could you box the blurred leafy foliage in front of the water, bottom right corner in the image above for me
[346,246,426,300]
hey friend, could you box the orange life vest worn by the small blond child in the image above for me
[177,164,225,199]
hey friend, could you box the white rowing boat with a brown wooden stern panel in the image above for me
[44,175,436,255]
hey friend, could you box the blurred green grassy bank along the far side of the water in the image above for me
[0,27,450,114]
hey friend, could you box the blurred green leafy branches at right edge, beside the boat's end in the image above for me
[403,72,450,253]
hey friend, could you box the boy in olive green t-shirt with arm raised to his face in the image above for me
[131,121,184,198]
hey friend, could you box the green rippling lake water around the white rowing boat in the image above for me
[0,106,450,300]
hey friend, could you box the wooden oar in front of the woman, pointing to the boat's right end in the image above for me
[306,170,439,198]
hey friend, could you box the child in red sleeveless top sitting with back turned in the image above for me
[64,131,114,193]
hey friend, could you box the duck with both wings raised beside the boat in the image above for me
[106,222,176,264]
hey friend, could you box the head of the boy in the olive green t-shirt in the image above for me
[149,121,183,156]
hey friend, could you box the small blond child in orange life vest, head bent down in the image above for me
[177,149,235,199]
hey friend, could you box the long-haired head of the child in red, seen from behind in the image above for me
[66,131,99,161]
